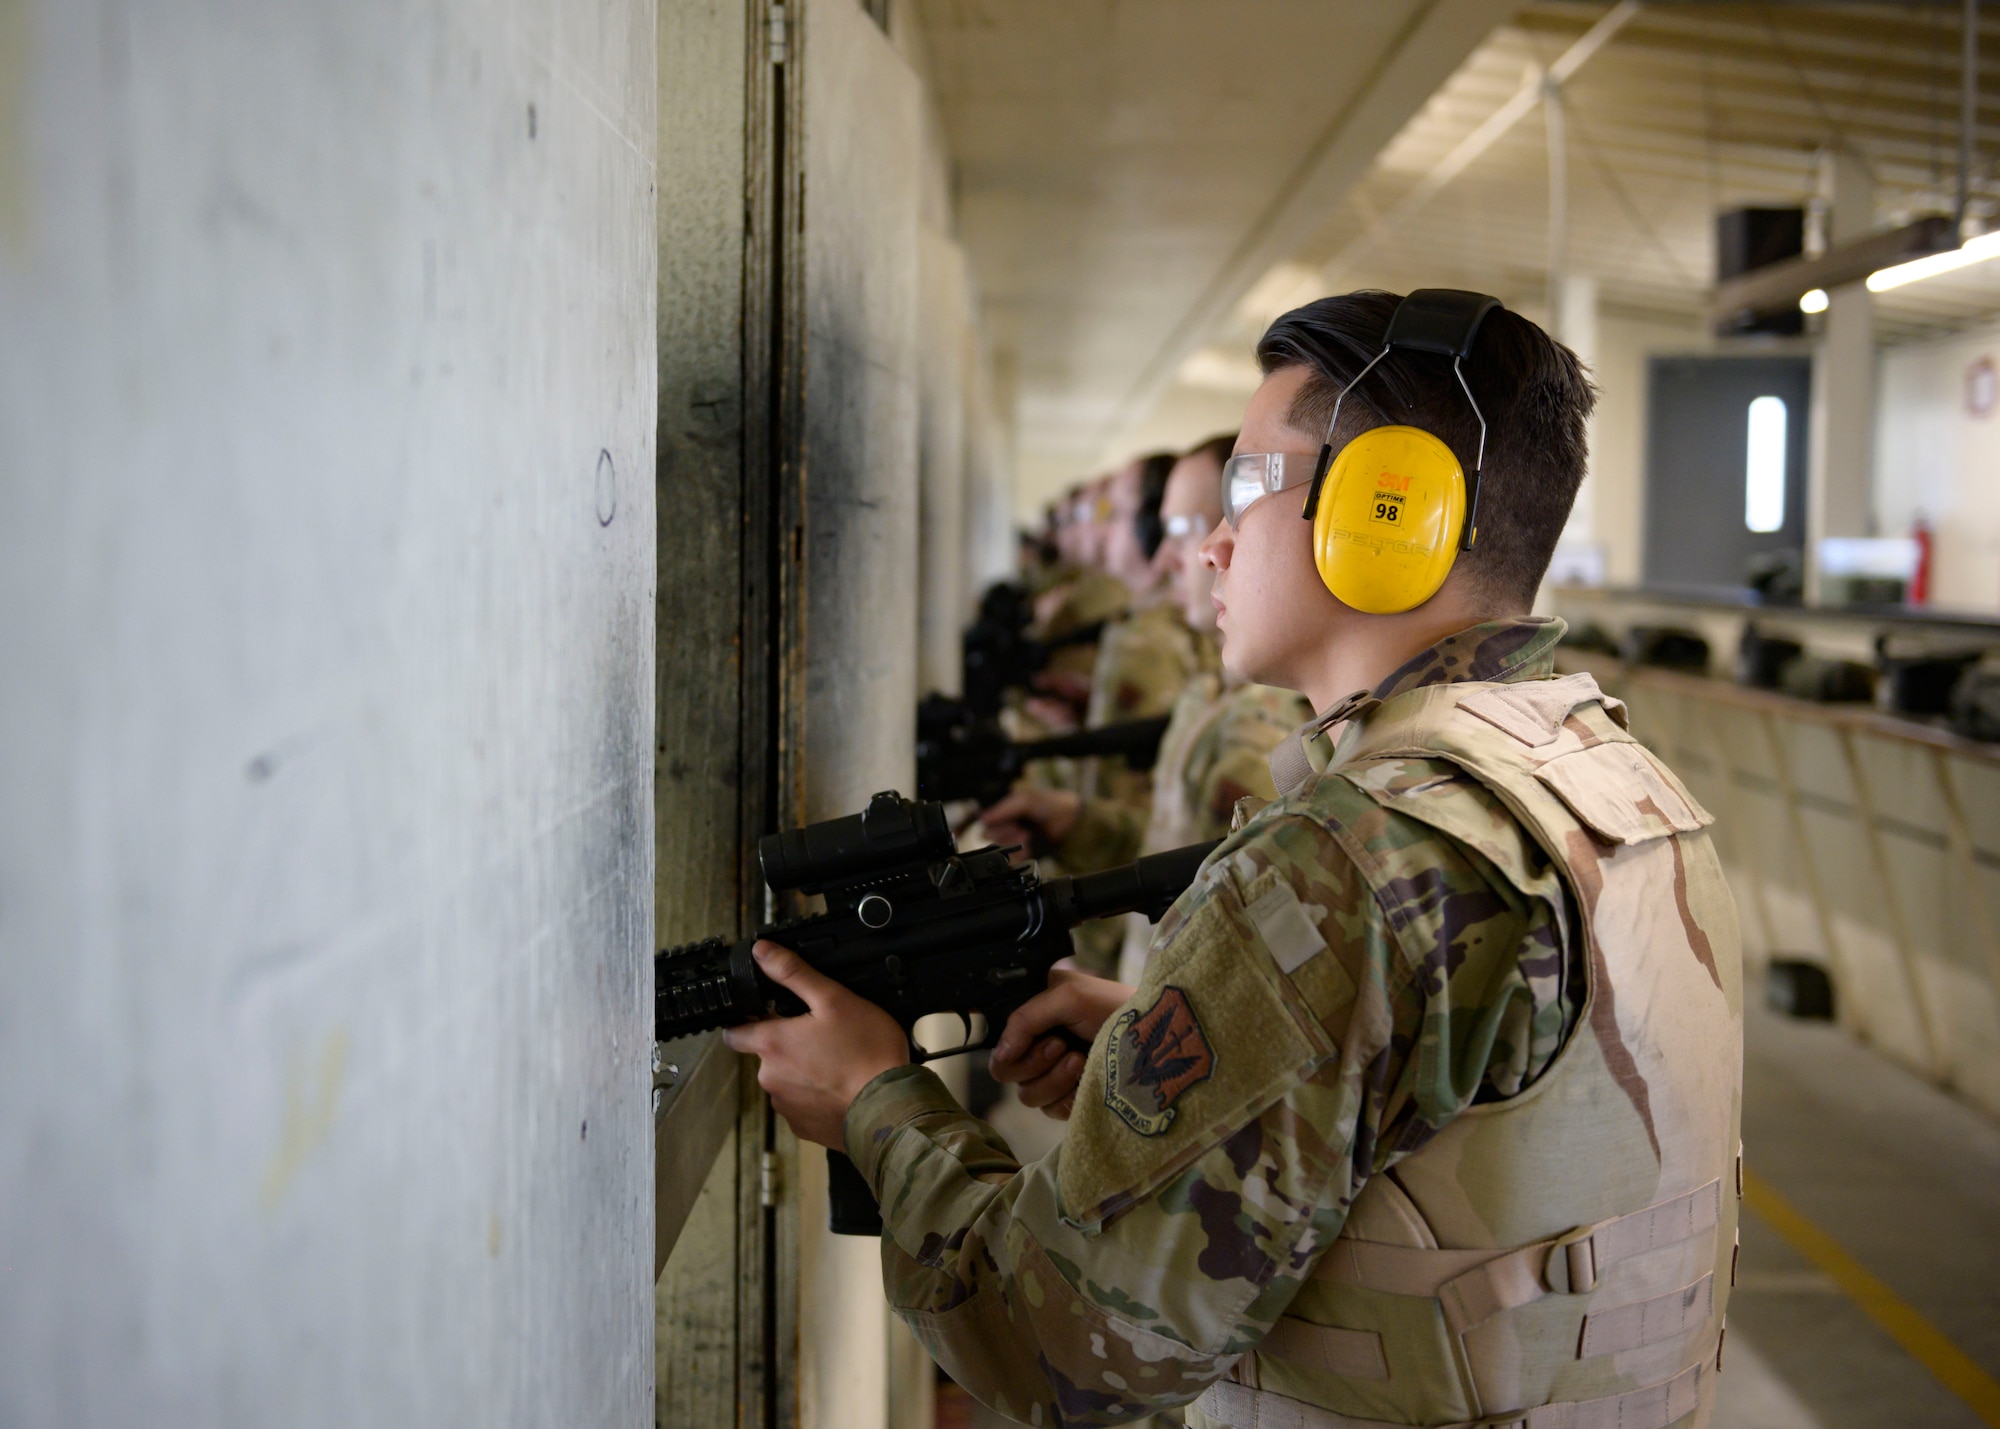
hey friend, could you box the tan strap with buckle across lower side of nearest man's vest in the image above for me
[1312,1179,1722,1335]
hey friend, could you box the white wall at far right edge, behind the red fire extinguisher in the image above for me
[1874,324,2000,610]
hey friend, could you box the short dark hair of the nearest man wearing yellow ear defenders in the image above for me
[1256,290,1598,606]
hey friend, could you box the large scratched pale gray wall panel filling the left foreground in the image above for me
[0,0,656,1429]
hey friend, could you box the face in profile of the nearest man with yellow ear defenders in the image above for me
[1202,366,1350,690]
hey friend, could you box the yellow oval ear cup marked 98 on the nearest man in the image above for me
[1312,426,1466,614]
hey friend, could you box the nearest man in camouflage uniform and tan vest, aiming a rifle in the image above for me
[728,294,1742,1429]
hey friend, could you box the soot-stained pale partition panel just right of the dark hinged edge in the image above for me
[792,0,920,1429]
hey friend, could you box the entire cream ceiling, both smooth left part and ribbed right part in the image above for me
[914,0,2000,500]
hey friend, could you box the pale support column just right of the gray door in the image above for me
[1806,150,1876,598]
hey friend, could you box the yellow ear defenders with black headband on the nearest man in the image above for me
[1304,288,1500,614]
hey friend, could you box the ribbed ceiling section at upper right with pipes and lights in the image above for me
[1244,0,2000,340]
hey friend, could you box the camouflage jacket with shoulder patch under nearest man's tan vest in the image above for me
[846,618,1586,1425]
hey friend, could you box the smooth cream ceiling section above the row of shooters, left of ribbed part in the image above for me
[916,0,1514,506]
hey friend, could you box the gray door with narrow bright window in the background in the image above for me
[1646,356,1812,586]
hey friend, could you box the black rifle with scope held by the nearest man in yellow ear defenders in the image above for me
[652,791,1216,1235]
